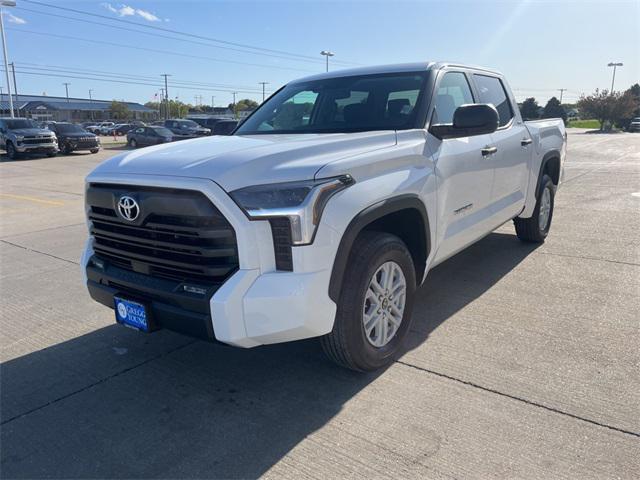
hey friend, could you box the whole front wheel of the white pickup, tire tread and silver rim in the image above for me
[320,231,416,371]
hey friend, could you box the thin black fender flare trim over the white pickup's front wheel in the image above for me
[329,194,431,303]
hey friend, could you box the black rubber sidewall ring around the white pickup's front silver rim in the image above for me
[336,234,416,370]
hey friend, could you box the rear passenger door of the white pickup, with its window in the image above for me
[473,73,533,223]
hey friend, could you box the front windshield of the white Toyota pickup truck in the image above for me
[234,72,426,135]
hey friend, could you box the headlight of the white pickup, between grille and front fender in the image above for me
[230,175,355,245]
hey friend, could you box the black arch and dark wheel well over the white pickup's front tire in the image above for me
[329,194,431,303]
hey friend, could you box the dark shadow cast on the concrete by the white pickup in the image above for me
[1,233,535,478]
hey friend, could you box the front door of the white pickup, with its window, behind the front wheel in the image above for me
[428,70,493,262]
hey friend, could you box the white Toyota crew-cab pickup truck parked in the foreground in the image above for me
[82,63,566,370]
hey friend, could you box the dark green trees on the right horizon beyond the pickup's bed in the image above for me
[520,83,640,130]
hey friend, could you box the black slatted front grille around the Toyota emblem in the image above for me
[87,184,238,287]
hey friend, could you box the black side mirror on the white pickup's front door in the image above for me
[429,103,499,140]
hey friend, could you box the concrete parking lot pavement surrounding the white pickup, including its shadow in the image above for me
[0,130,640,479]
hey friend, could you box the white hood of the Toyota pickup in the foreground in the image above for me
[92,131,396,191]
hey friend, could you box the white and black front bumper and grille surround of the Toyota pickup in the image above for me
[82,175,340,347]
